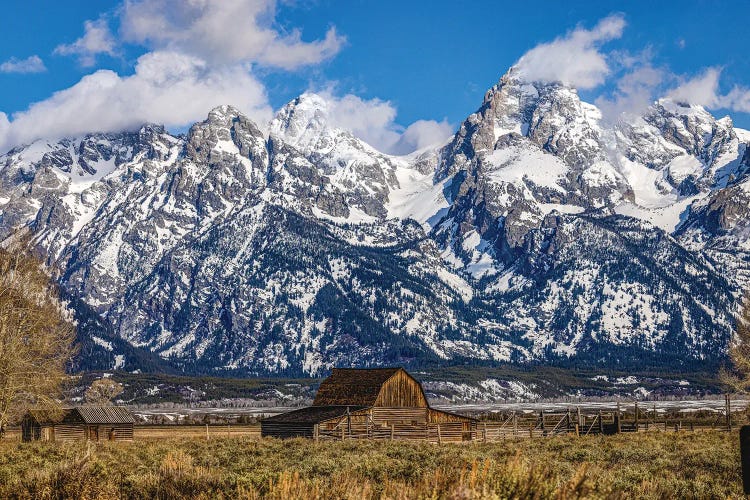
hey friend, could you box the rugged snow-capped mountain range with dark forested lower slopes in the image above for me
[0,69,750,374]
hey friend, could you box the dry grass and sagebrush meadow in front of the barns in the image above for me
[0,431,744,499]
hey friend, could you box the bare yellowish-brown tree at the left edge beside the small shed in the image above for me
[0,245,75,437]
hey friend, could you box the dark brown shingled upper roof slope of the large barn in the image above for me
[313,368,402,406]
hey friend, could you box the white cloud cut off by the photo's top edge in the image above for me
[120,0,345,69]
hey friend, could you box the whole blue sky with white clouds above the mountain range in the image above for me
[0,0,750,152]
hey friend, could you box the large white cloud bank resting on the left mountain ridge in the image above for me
[0,52,272,151]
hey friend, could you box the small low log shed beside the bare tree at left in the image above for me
[21,406,135,441]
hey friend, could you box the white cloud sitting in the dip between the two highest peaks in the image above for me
[318,89,454,154]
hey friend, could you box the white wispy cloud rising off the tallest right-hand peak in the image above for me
[516,14,625,89]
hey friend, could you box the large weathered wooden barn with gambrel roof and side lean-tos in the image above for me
[261,368,476,442]
